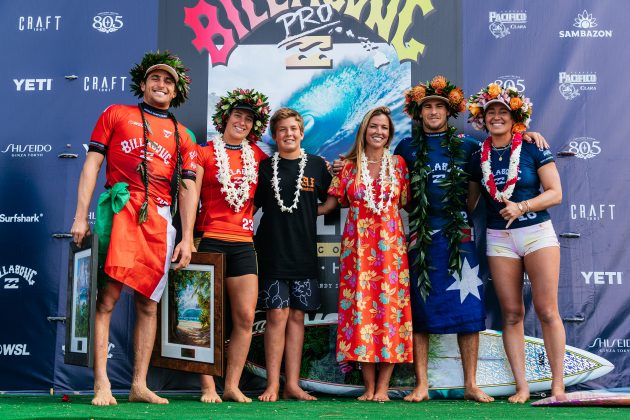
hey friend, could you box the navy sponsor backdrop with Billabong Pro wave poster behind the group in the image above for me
[0,0,630,391]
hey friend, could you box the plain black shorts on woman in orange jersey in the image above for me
[198,238,258,277]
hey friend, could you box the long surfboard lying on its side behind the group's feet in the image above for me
[247,314,614,399]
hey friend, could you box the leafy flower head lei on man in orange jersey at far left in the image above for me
[129,51,190,108]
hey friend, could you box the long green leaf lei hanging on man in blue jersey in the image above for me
[409,126,469,301]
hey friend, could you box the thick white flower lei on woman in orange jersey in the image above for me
[212,136,258,213]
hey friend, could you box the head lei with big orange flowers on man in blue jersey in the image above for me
[404,75,466,120]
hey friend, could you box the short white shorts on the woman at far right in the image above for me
[486,220,560,258]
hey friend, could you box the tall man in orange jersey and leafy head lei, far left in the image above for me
[72,52,197,406]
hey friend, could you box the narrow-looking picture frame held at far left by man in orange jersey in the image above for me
[64,235,98,368]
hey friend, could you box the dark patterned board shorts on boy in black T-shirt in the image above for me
[258,279,321,312]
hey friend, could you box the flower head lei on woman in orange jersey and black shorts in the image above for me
[212,88,270,141]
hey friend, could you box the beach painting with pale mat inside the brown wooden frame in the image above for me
[160,264,215,363]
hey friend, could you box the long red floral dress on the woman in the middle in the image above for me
[328,156,413,363]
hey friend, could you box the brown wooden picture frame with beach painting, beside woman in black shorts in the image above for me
[151,252,225,376]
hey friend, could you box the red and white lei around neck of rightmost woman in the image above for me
[481,133,523,203]
